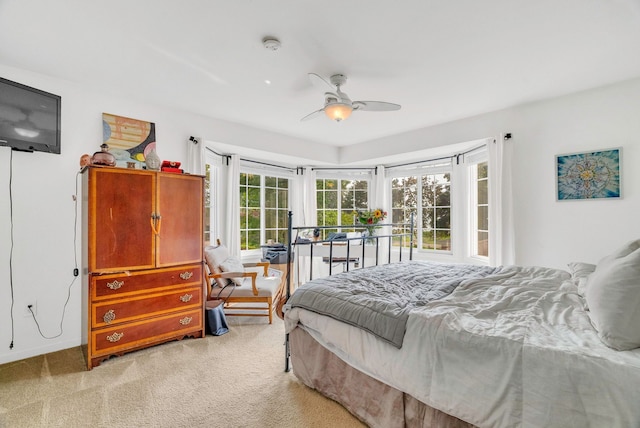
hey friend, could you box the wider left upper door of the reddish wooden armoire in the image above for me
[88,168,156,273]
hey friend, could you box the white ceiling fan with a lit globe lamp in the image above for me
[300,73,400,122]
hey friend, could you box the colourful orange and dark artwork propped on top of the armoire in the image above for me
[102,113,156,169]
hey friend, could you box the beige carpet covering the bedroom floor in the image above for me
[0,317,364,428]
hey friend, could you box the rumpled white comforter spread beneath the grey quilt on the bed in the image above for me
[285,267,640,427]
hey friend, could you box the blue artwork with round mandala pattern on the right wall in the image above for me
[556,148,622,201]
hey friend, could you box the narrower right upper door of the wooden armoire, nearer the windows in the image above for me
[156,174,204,267]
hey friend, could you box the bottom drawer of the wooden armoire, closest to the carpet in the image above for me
[91,309,203,357]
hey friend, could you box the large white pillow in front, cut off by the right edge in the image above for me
[585,239,640,351]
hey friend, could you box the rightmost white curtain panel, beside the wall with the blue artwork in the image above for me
[489,135,515,266]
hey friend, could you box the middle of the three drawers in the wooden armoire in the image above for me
[91,287,202,328]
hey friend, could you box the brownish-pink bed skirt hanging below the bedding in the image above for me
[289,328,473,428]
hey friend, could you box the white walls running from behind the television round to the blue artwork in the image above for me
[0,61,640,363]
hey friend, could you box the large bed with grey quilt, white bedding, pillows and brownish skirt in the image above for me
[284,222,640,427]
